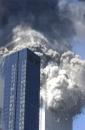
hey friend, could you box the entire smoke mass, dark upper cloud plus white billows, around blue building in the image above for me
[0,0,85,115]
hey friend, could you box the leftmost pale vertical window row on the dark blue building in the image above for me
[8,64,16,130]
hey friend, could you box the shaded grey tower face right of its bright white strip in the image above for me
[45,109,72,130]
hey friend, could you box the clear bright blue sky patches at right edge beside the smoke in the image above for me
[73,41,85,130]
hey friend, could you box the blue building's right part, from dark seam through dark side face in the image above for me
[16,50,40,130]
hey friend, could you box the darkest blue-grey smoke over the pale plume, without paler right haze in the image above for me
[0,0,75,51]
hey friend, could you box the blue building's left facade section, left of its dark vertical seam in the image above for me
[3,53,18,130]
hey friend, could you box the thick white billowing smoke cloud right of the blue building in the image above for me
[43,52,85,115]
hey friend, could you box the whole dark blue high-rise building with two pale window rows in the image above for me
[3,49,40,130]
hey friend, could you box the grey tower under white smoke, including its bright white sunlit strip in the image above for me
[39,101,72,130]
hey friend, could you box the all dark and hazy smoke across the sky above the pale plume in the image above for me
[0,0,85,48]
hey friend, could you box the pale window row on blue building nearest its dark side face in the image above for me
[19,60,26,130]
